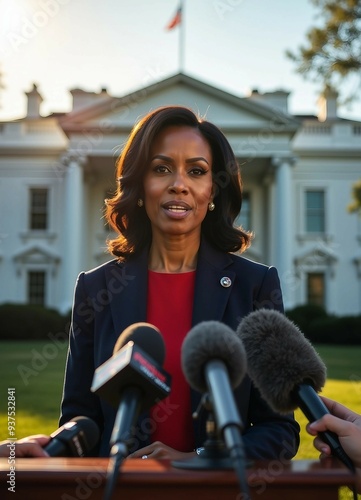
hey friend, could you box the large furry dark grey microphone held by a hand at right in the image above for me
[236,309,355,471]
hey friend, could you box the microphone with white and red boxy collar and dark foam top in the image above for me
[91,323,171,457]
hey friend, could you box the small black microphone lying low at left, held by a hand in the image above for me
[44,417,99,457]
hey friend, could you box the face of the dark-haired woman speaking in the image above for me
[144,126,213,240]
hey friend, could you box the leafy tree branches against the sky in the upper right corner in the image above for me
[286,0,361,101]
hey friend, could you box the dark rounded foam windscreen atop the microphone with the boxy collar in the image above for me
[113,322,165,366]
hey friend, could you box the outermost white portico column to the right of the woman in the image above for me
[272,157,295,309]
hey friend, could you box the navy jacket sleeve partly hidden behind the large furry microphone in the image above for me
[243,267,300,460]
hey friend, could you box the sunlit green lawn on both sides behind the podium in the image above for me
[0,341,361,500]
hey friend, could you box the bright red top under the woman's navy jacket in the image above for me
[147,271,196,451]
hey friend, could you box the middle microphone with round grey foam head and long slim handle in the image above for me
[181,321,250,498]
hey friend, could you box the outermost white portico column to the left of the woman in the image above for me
[60,156,85,312]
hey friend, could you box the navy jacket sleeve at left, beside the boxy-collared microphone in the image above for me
[59,273,103,454]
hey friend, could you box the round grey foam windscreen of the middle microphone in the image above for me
[181,321,247,392]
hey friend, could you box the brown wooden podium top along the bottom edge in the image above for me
[0,458,355,500]
